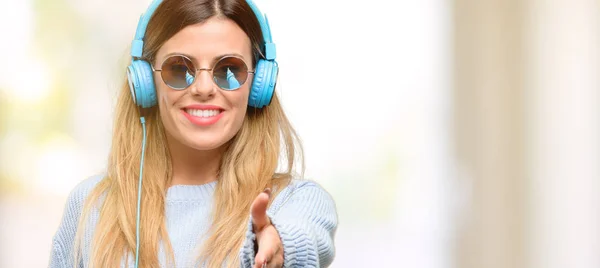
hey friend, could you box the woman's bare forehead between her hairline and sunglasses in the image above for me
[157,17,252,64]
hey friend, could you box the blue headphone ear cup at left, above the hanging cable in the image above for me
[127,60,157,108]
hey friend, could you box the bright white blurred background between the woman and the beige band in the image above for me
[257,0,453,268]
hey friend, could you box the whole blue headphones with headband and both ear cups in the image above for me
[127,0,279,108]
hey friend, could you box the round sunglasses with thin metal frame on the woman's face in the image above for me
[152,55,254,90]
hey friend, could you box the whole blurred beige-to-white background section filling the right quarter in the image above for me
[453,0,600,268]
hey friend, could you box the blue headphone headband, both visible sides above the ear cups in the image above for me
[131,0,277,60]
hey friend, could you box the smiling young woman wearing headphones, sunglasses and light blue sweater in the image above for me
[49,0,337,268]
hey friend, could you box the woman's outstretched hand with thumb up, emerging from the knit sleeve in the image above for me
[251,189,283,268]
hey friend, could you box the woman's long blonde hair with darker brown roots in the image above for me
[75,0,304,267]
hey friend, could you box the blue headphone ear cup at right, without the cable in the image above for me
[248,60,279,108]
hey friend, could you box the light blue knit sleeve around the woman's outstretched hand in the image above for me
[241,182,338,268]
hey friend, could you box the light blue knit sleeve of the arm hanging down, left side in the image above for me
[48,177,101,268]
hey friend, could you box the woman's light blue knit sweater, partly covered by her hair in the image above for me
[49,176,337,268]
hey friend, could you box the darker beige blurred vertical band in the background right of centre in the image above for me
[454,0,528,268]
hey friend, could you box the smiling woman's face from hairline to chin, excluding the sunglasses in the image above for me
[154,18,253,153]
